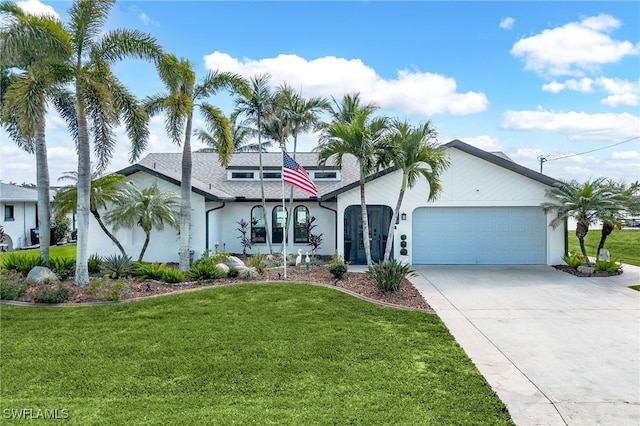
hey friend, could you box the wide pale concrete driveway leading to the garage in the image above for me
[411,266,640,426]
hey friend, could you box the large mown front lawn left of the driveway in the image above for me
[0,283,512,425]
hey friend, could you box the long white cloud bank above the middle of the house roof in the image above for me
[204,52,488,117]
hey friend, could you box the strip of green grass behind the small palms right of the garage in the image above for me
[569,229,640,266]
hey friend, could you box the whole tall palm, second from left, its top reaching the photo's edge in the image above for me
[68,0,162,285]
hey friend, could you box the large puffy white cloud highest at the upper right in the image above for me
[510,14,639,76]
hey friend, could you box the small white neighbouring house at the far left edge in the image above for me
[0,182,39,250]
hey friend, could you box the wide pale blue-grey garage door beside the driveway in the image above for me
[412,207,547,265]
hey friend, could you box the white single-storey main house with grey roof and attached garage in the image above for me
[89,140,566,264]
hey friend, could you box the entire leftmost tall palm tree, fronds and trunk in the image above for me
[0,2,71,261]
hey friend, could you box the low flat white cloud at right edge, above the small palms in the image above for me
[500,109,640,142]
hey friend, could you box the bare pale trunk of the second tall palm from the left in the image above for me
[73,93,91,286]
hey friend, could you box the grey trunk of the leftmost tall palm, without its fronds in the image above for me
[36,117,51,262]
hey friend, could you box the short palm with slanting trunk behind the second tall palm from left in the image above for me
[53,172,127,256]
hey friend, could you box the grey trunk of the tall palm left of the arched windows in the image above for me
[179,114,193,273]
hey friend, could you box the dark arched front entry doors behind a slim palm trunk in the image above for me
[344,205,393,265]
